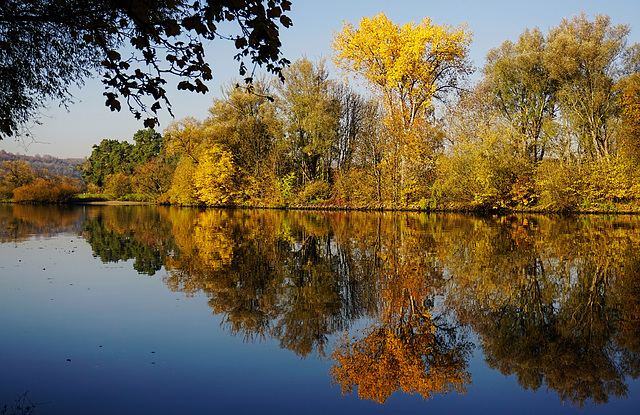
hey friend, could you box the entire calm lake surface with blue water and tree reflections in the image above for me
[0,205,640,414]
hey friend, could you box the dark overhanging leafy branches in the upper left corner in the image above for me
[0,0,292,136]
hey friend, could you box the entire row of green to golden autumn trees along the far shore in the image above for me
[5,13,640,211]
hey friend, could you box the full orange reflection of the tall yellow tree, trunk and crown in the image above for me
[331,214,470,403]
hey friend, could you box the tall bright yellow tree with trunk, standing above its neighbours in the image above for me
[333,13,472,201]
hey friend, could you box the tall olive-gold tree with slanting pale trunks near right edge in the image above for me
[546,14,629,159]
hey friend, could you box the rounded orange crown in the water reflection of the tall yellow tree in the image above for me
[331,300,470,403]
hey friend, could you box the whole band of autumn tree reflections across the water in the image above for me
[20,207,640,406]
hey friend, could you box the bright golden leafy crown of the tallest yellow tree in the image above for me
[332,13,471,108]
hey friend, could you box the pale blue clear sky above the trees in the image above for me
[0,0,640,157]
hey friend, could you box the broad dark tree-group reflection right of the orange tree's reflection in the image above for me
[445,214,640,407]
